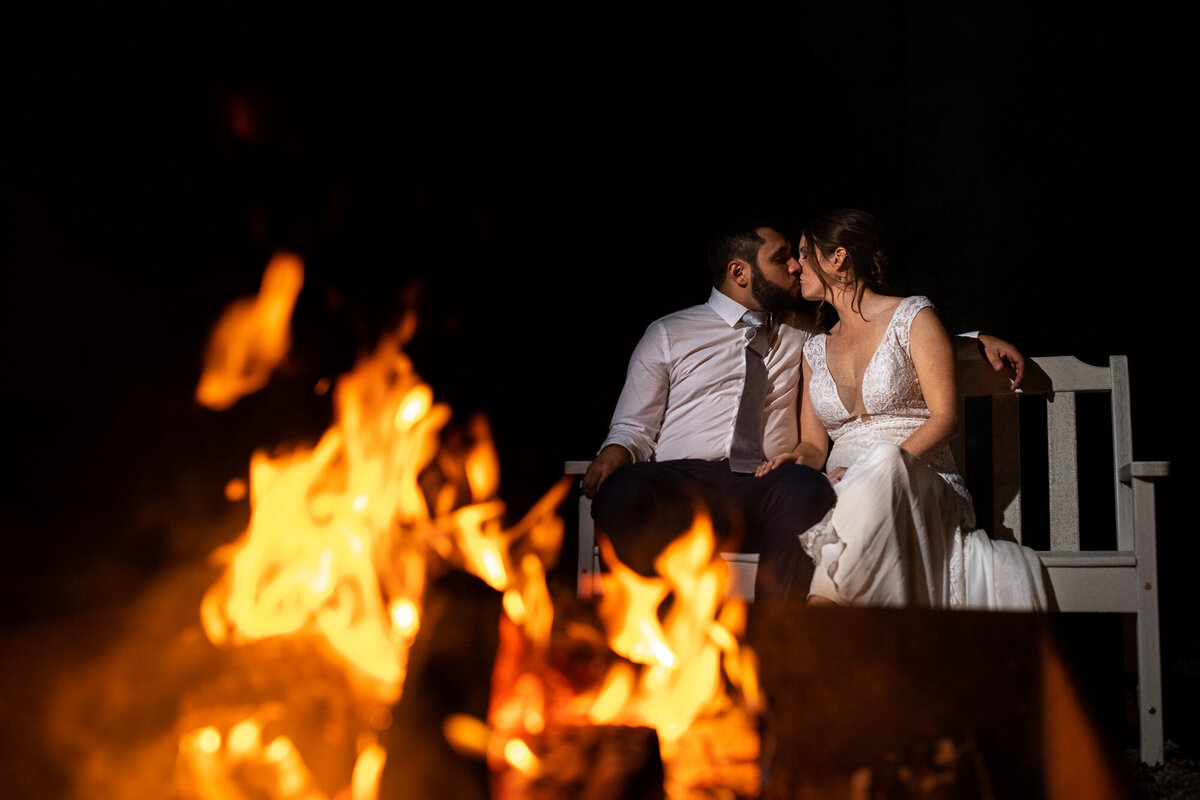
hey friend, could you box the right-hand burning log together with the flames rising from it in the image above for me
[477,521,761,800]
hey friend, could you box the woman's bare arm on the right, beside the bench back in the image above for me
[900,308,959,457]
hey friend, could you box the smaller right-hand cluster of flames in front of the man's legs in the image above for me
[489,515,763,800]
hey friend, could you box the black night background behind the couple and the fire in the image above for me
[0,2,1196,786]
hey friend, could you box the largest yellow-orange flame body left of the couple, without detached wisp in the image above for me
[202,321,450,702]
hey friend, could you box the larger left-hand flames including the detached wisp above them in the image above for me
[180,257,568,800]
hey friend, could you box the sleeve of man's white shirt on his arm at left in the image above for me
[600,324,671,462]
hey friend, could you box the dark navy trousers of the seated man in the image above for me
[592,459,835,602]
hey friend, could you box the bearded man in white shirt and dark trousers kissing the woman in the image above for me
[583,219,1025,602]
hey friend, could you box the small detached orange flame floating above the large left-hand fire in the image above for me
[196,253,304,410]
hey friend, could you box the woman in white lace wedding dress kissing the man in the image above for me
[758,210,1046,610]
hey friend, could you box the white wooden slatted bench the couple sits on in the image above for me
[565,355,1170,765]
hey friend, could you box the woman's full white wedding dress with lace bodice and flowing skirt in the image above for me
[800,296,1046,610]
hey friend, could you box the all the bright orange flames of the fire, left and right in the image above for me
[179,257,761,800]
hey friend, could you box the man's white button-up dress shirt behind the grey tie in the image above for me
[600,288,812,462]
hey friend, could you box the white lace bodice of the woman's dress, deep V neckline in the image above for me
[804,295,966,503]
